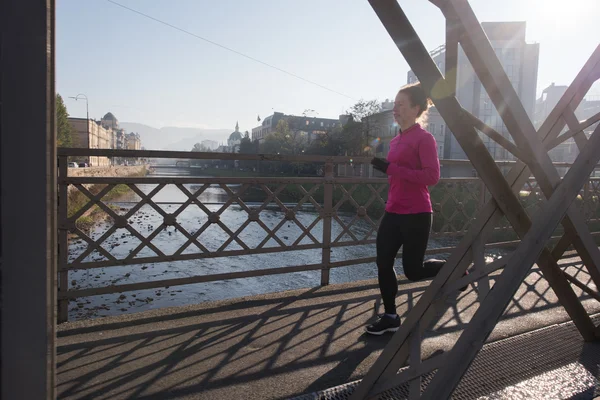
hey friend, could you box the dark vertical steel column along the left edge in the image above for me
[0,0,56,400]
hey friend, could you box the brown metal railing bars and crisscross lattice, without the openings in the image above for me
[58,149,600,321]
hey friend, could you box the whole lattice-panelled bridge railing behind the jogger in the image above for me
[58,149,600,321]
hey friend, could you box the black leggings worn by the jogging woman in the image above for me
[377,212,445,314]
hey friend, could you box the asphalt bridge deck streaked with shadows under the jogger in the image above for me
[57,259,600,400]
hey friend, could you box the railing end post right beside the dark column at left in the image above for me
[57,156,69,323]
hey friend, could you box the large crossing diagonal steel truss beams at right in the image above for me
[351,0,600,400]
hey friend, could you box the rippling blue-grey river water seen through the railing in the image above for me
[69,170,492,320]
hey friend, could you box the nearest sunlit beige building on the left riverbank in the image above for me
[69,118,113,167]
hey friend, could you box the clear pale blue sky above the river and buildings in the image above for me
[56,0,600,132]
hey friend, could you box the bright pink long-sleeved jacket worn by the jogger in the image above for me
[385,124,440,214]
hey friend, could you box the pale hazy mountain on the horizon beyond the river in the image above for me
[119,122,233,151]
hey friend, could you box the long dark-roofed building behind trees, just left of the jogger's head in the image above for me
[252,112,347,143]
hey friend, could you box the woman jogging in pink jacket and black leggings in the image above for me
[367,84,444,335]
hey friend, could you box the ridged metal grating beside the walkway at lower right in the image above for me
[291,316,600,400]
